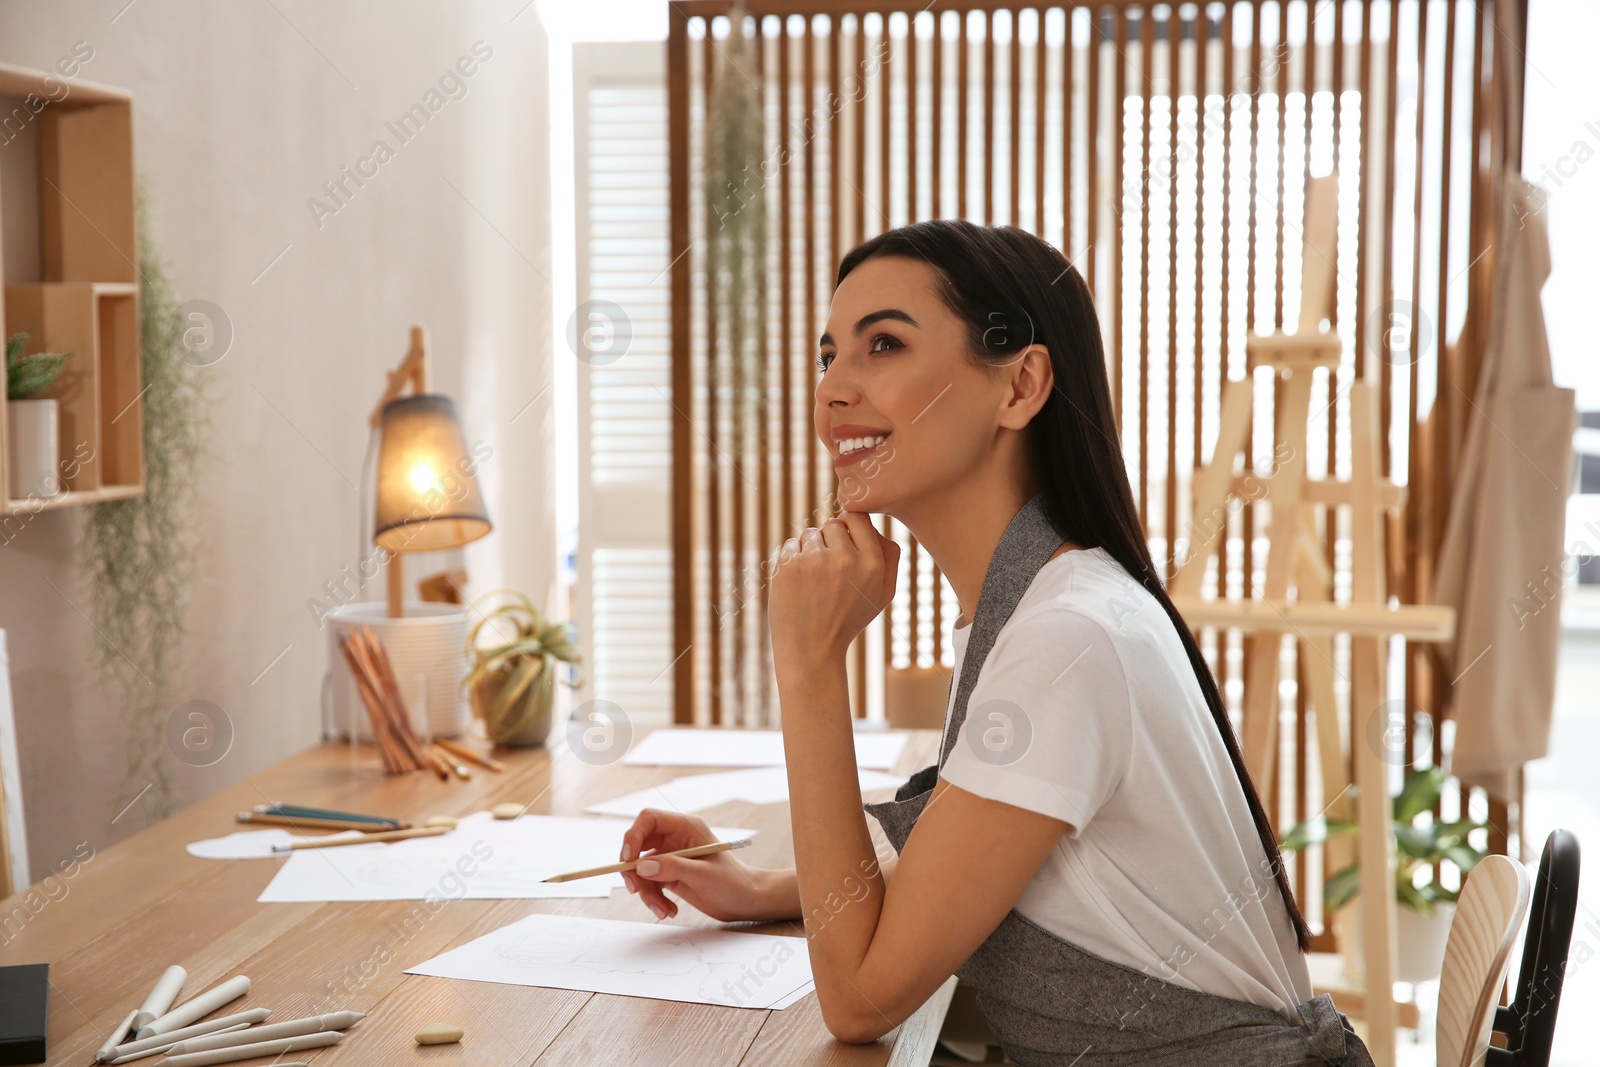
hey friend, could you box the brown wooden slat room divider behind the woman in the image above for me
[667,0,1523,940]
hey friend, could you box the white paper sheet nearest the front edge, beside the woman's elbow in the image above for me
[406,915,813,1009]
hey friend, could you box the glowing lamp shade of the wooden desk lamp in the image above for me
[373,394,491,552]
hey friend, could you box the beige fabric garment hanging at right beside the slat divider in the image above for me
[1434,173,1578,801]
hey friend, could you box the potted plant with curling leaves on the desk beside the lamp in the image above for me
[466,589,579,745]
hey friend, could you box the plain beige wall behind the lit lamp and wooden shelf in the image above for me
[0,0,566,877]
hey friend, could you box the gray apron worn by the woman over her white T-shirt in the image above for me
[864,496,1373,1067]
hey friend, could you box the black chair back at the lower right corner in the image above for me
[1485,830,1578,1067]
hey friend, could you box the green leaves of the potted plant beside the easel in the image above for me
[1278,766,1488,915]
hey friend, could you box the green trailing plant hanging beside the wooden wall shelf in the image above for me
[80,190,208,821]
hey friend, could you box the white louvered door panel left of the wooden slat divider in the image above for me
[573,42,672,723]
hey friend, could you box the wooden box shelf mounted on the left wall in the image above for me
[0,64,144,514]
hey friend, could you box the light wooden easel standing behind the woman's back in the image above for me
[1170,173,1456,1067]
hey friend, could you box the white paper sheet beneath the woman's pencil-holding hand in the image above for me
[256,811,755,904]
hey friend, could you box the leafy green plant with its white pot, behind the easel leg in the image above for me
[1278,766,1488,984]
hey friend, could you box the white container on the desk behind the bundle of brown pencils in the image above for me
[325,601,472,741]
